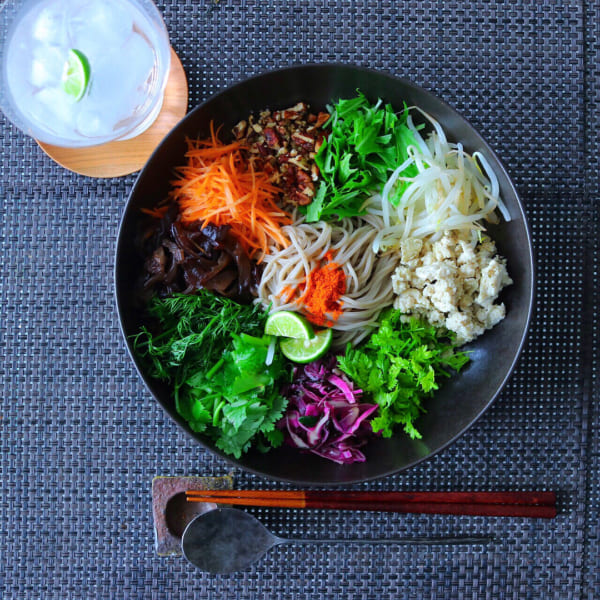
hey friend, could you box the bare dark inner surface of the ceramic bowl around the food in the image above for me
[115,65,533,485]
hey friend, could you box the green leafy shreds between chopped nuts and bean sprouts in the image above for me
[301,92,417,223]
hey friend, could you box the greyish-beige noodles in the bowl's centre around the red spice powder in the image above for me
[258,215,398,348]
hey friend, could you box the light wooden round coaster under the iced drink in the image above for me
[36,48,188,177]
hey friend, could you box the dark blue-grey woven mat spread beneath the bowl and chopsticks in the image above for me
[0,0,600,600]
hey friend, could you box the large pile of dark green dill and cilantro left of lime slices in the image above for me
[134,291,290,458]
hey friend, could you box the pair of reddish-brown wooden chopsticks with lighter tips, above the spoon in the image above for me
[186,490,556,519]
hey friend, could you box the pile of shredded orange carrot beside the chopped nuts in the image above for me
[172,122,292,262]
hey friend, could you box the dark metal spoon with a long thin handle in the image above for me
[181,508,493,573]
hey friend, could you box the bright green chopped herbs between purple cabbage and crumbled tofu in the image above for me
[338,310,469,439]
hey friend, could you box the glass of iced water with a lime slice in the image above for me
[0,0,170,147]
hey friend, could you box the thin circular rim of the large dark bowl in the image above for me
[113,62,536,487]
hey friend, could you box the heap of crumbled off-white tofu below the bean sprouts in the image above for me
[392,231,512,344]
